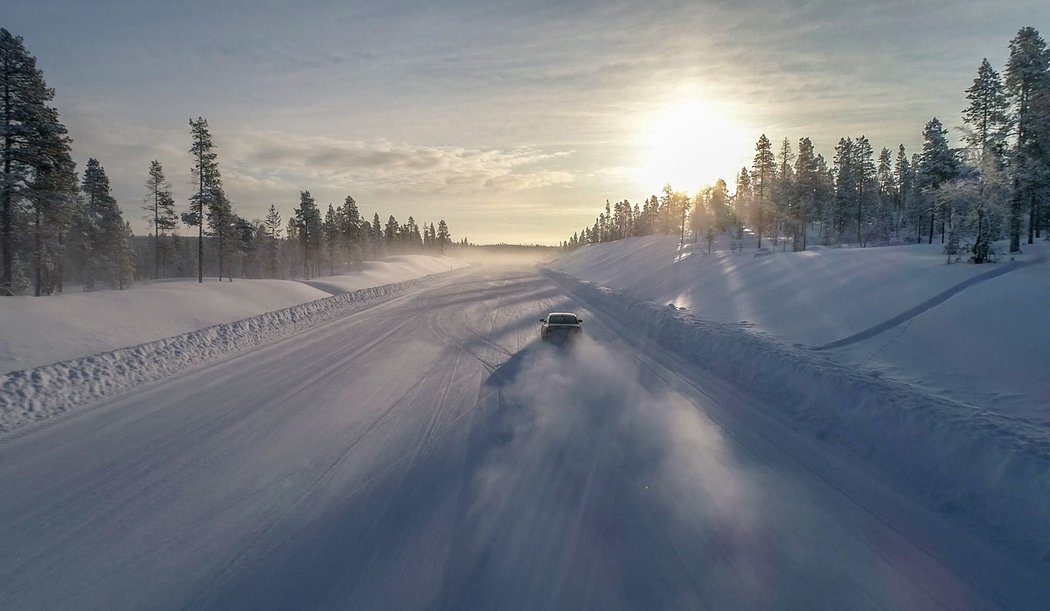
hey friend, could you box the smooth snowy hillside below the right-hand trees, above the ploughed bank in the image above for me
[550,236,1050,426]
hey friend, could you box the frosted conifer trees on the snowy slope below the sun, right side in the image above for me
[562,27,1050,262]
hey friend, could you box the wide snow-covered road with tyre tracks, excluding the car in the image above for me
[0,268,1050,609]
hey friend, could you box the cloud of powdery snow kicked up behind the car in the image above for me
[453,339,773,608]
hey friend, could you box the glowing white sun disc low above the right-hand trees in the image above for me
[639,99,748,193]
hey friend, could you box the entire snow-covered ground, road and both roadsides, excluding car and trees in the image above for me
[0,243,1050,609]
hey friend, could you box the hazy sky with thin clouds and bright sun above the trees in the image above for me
[0,0,1050,244]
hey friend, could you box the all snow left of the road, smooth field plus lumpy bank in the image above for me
[0,255,466,434]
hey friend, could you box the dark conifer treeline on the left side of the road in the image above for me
[0,28,452,295]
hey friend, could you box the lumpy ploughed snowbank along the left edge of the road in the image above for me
[0,276,455,434]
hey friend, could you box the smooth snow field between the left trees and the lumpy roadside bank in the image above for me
[0,255,464,374]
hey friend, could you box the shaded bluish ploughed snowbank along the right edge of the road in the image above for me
[546,270,1050,557]
